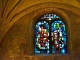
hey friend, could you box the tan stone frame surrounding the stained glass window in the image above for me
[30,8,72,55]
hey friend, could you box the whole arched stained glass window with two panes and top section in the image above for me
[34,14,67,54]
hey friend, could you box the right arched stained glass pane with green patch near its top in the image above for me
[51,20,67,54]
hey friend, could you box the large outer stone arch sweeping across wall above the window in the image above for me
[0,2,80,49]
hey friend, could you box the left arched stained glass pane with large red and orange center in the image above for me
[35,21,49,53]
